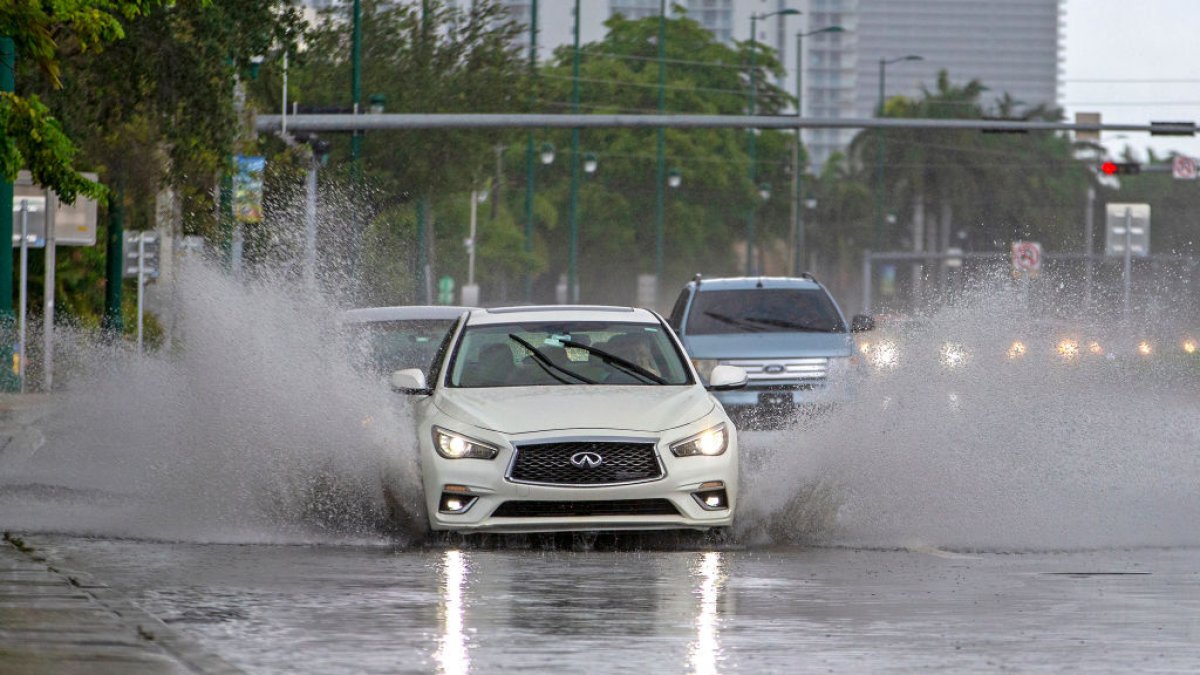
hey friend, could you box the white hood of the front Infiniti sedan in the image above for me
[434,384,715,434]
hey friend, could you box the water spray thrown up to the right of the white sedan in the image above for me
[742,270,1200,550]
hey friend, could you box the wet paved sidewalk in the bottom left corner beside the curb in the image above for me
[0,534,240,675]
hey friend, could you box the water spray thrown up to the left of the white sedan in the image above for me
[6,262,424,542]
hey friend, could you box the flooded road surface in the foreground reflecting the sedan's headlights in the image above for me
[35,537,1200,673]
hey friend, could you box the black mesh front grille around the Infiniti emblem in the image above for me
[509,441,662,485]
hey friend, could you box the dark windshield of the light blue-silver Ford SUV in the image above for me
[688,288,846,335]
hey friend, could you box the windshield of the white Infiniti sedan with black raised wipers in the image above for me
[450,322,691,387]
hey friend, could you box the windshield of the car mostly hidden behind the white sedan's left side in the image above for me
[347,318,457,377]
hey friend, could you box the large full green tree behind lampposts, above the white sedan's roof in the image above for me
[528,9,790,301]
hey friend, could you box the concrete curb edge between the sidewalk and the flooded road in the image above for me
[0,532,246,675]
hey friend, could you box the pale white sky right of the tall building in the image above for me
[1060,0,1200,156]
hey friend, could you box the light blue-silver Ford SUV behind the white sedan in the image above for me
[670,274,875,414]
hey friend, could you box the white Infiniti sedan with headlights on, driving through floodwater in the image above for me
[391,306,746,532]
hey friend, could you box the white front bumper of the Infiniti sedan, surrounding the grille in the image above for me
[420,425,738,533]
